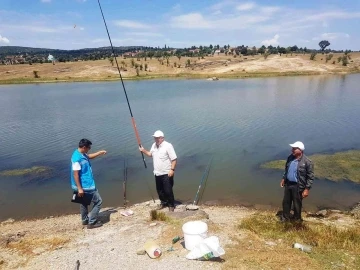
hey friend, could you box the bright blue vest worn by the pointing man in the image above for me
[70,149,96,191]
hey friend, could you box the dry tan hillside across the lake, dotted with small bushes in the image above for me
[0,53,360,83]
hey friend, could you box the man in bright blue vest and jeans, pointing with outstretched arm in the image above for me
[71,139,106,229]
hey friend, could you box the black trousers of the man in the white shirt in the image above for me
[155,174,175,207]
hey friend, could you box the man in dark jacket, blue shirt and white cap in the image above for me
[280,141,314,221]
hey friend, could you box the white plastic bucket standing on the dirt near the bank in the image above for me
[182,221,208,251]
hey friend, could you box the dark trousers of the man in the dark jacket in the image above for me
[283,182,302,220]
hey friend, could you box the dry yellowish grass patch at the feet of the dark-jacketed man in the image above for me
[225,213,360,269]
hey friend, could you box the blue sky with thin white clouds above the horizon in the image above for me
[0,0,360,51]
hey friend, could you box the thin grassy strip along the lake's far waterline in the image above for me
[0,69,360,85]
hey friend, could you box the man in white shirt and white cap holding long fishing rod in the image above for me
[139,130,177,212]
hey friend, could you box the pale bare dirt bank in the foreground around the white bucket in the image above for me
[0,202,360,270]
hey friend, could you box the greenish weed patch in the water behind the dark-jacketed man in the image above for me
[260,150,360,183]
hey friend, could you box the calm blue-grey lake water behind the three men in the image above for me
[0,74,360,220]
